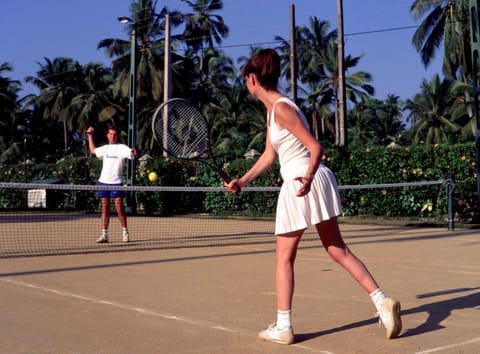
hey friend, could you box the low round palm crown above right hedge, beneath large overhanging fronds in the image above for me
[405,74,467,145]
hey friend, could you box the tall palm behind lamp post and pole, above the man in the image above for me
[98,0,188,150]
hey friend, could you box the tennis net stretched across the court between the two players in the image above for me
[0,180,448,258]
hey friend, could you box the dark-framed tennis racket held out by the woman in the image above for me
[152,98,240,193]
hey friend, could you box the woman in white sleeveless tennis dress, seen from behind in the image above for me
[225,49,402,344]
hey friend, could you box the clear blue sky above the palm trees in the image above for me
[0,0,441,99]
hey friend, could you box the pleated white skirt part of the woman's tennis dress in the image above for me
[275,164,342,235]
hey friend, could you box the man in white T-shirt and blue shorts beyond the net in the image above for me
[87,127,137,243]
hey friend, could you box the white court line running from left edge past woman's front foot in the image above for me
[0,279,335,354]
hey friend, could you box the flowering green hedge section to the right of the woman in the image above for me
[326,143,477,219]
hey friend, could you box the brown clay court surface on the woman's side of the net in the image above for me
[0,220,480,354]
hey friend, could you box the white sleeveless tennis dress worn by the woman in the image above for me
[268,97,342,235]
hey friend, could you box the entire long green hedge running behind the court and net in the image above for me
[0,143,477,220]
